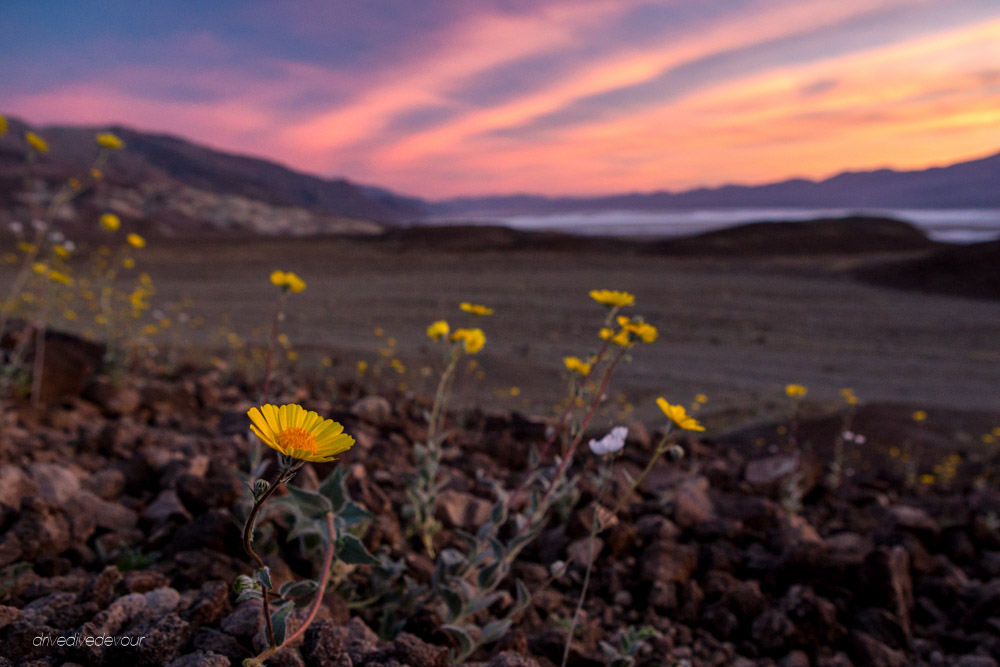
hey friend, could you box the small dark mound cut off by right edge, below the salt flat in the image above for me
[854,241,1000,301]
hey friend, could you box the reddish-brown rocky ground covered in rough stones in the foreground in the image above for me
[0,348,1000,667]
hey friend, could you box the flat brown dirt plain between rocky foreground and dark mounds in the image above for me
[70,238,1000,434]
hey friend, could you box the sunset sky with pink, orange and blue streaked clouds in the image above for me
[0,0,1000,199]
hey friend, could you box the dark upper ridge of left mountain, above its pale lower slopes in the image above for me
[0,120,424,224]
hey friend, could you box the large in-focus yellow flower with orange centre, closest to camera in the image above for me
[247,403,354,463]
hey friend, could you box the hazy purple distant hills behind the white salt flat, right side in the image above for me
[430,153,1000,219]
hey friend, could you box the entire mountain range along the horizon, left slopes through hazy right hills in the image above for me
[0,120,1000,233]
